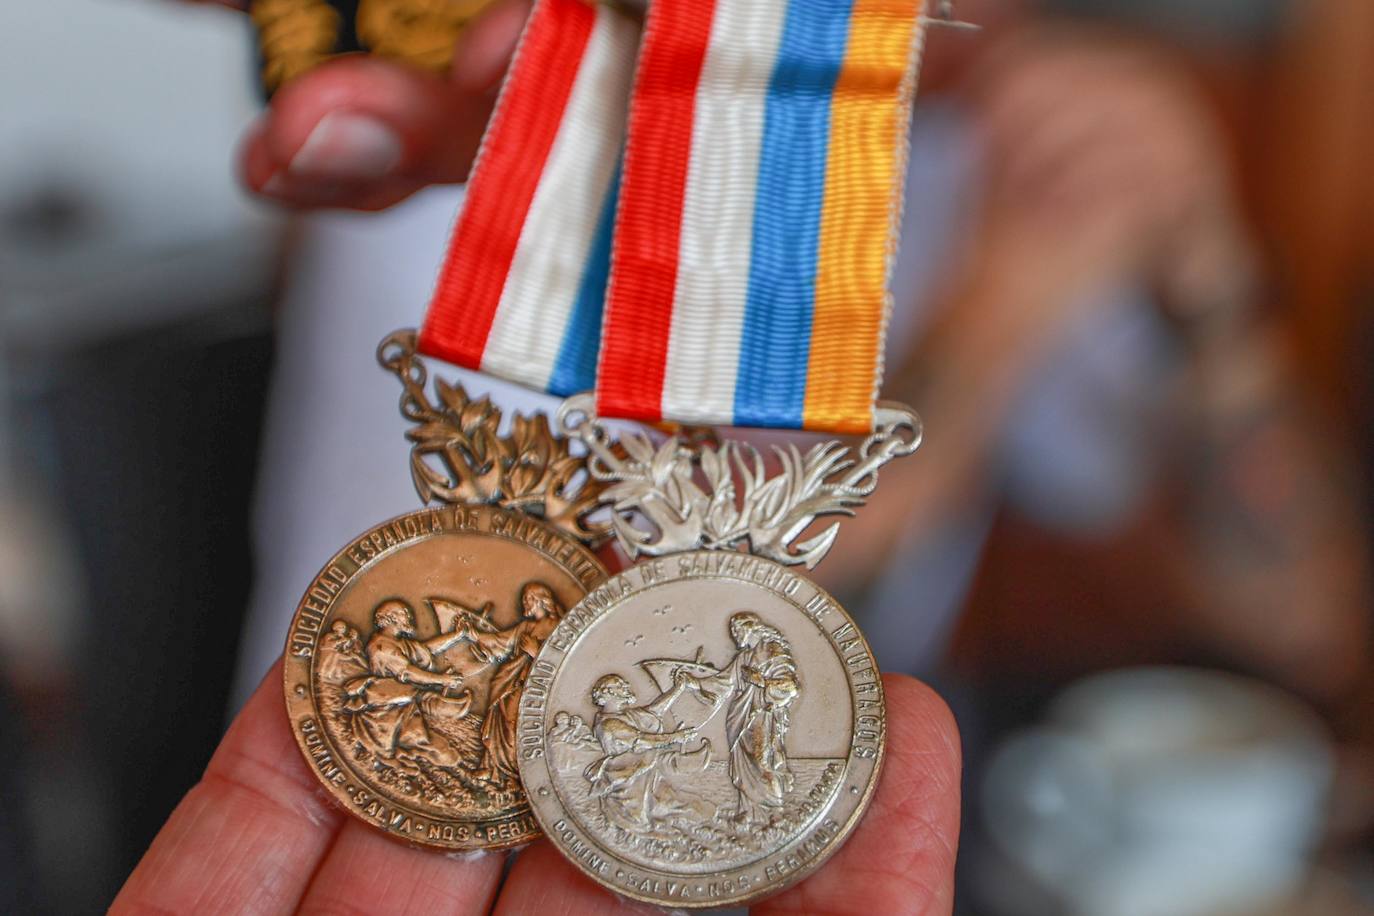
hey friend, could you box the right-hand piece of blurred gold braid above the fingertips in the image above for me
[357,0,493,73]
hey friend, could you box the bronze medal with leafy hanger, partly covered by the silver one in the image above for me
[284,332,610,849]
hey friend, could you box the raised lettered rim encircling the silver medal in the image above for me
[517,549,888,909]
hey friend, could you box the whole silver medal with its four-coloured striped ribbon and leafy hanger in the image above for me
[517,0,925,908]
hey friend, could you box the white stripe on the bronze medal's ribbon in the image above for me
[482,5,640,390]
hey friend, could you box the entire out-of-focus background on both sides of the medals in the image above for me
[0,0,1374,916]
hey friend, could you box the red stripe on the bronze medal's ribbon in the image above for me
[419,0,596,369]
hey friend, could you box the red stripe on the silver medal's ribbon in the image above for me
[596,0,716,422]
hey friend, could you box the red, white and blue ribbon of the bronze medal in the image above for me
[419,0,640,394]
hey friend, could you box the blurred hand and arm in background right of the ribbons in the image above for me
[820,4,1369,698]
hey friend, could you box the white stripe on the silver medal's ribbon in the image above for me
[662,0,787,423]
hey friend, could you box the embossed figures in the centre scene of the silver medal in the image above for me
[550,611,807,862]
